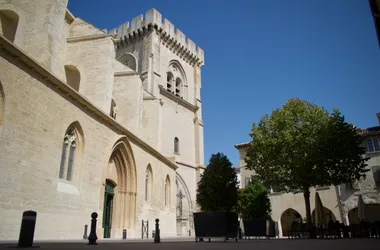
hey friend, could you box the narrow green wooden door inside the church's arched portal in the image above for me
[103,180,115,238]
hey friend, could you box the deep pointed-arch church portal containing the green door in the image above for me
[99,137,137,238]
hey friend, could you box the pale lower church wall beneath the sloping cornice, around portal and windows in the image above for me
[0,36,176,239]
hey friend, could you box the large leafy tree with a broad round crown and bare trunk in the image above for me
[245,98,367,230]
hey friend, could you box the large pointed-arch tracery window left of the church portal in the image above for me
[58,121,84,182]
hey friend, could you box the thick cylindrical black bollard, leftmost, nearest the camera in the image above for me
[18,210,37,247]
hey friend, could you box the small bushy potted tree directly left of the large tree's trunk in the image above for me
[236,176,272,220]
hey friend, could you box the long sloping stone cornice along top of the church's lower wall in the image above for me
[0,35,178,170]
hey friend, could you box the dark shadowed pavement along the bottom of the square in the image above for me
[0,238,380,250]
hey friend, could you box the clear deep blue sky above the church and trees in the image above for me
[68,0,380,166]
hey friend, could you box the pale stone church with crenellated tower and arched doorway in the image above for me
[0,0,204,240]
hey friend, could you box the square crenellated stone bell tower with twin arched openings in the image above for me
[108,9,204,234]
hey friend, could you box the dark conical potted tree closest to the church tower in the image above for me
[197,153,238,212]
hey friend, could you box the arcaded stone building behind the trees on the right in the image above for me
[235,113,380,236]
